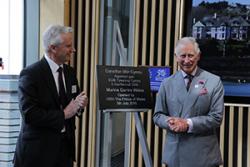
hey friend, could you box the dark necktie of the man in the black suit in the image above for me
[57,67,67,108]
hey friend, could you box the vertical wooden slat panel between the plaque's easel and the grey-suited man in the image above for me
[130,0,181,167]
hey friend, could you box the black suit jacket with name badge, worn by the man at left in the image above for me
[14,58,79,167]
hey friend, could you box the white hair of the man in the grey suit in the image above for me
[174,37,201,56]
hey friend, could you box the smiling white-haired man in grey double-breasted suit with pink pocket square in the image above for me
[153,37,224,167]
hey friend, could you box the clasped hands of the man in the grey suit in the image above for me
[167,117,188,133]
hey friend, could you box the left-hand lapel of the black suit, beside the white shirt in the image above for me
[41,58,60,106]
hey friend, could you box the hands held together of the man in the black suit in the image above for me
[64,91,88,119]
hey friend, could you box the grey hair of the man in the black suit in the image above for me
[43,25,73,53]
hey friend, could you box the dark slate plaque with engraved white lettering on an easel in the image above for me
[97,65,152,111]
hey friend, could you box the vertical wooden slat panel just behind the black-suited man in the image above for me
[65,0,100,167]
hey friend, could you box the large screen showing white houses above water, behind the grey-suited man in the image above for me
[186,0,250,104]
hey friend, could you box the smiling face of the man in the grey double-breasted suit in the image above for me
[175,42,200,74]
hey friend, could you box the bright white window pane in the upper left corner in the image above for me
[0,0,24,75]
